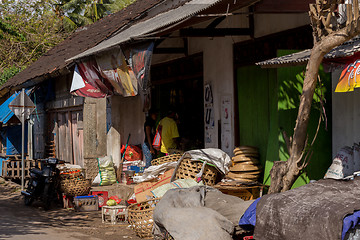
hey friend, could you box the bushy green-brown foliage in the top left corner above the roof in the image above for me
[0,0,67,75]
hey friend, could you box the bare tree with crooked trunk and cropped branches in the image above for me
[269,0,360,193]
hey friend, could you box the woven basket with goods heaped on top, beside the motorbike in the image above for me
[60,168,91,196]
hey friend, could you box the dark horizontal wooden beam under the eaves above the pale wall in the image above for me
[180,28,251,37]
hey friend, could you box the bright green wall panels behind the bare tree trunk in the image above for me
[237,50,331,187]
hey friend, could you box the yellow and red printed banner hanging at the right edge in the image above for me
[335,60,360,92]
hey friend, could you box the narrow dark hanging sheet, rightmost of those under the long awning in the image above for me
[130,42,154,112]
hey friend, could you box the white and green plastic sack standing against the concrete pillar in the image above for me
[98,156,116,186]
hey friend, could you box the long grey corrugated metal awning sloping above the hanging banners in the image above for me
[67,0,222,61]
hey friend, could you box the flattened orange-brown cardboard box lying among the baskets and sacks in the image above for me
[134,169,175,202]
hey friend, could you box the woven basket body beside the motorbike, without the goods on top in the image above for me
[60,178,91,196]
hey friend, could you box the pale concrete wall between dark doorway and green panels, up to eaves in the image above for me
[153,9,309,155]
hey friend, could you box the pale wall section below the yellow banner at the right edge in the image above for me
[331,70,360,157]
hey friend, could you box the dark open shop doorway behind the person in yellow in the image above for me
[151,55,204,150]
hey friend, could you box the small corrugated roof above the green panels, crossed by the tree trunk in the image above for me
[256,37,360,68]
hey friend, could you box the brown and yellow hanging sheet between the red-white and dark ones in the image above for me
[96,49,138,97]
